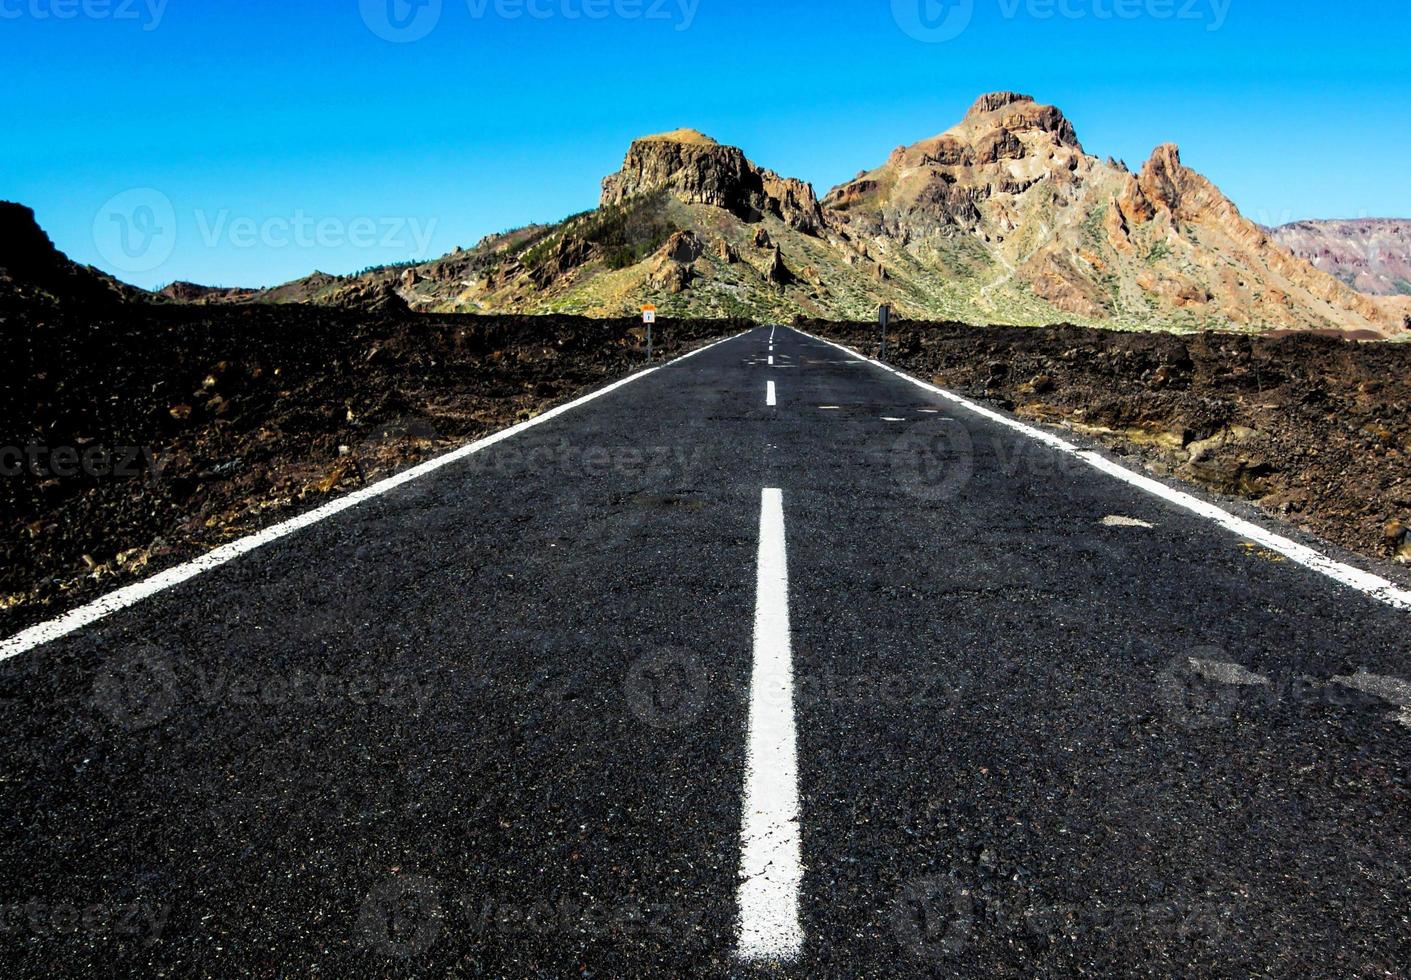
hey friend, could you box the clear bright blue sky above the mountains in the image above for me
[0,0,1411,286]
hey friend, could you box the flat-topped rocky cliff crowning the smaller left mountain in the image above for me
[601,130,823,234]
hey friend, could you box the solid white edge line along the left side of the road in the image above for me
[0,331,748,663]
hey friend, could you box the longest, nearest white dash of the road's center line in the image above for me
[738,489,803,963]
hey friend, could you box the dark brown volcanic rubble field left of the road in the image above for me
[0,303,746,636]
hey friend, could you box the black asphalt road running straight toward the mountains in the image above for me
[0,327,1411,977]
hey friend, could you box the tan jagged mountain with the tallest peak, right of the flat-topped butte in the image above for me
[824,92,1401,334]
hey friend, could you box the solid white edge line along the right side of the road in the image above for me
[792,327,1411,611]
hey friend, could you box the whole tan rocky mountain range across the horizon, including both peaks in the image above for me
[11,92,1411,338]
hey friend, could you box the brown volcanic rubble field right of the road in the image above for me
[800,320,1411,572]
